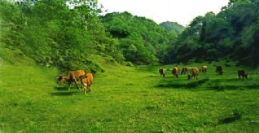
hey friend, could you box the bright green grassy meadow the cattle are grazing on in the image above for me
[0,49,259,132]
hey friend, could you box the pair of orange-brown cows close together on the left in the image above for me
[57,70,94,94]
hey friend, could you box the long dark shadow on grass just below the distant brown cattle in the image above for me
[156,79,209,88]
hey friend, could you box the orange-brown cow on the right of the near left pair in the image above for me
[80,73,94,94]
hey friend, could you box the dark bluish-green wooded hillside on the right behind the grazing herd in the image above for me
[171,0,259,66]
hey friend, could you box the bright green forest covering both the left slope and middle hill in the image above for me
[0,0,176,72]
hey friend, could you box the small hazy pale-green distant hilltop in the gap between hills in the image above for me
[159,21,184,35]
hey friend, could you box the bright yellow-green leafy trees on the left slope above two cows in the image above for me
[0,0,124,71]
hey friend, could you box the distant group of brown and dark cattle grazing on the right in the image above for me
[159,66,248,80]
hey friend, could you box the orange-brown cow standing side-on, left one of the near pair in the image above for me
[57,70,85,90]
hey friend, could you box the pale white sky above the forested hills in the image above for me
[98,0,229,26]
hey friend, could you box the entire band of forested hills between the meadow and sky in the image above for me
[0,0,259,72]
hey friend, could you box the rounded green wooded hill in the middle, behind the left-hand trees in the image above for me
[101,12,179,64]
